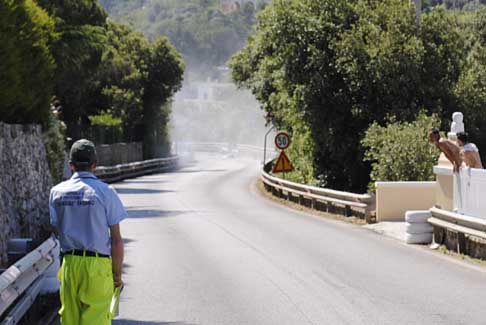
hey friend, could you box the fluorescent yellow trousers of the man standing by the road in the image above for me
[59,255,114,325]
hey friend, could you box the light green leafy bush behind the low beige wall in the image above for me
[362,112,440,189]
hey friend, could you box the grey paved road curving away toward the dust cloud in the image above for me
[114,156,486,325]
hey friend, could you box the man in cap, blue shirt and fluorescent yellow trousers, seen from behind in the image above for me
[49,140,127,325]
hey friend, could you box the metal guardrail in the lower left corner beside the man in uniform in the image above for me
[0,238,58,325]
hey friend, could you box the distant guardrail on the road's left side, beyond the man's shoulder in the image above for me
[95,157,179,183]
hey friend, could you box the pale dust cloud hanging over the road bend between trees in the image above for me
[169,73,266,147]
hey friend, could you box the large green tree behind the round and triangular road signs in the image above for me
[231,0,461,191]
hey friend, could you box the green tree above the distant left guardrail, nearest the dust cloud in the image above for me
[96,20,184,158]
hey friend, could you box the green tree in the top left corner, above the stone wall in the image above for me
[0,0,56,123]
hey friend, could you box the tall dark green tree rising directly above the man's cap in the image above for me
[38,0,106,128]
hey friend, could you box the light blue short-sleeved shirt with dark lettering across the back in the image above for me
[49,172,127,255]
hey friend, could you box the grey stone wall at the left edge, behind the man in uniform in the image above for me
[0,122,52,264]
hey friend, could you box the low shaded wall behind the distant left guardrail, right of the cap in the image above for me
[96,142,143,166]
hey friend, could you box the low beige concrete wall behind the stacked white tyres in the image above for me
[376,182,436,222]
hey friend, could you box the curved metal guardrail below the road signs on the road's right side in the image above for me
[261,163,374,223]
